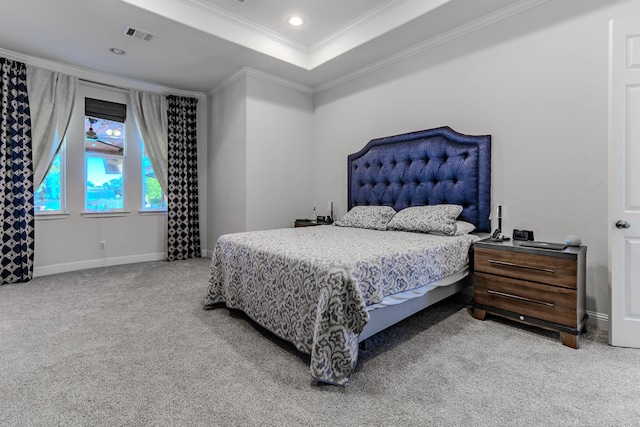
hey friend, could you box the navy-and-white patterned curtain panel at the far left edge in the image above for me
[0,58,34,284]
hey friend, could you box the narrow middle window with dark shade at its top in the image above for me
[84,98,126,212]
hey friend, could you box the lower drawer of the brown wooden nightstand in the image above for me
[473,272,580,328]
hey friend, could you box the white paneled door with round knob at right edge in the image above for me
[609,17,640,348]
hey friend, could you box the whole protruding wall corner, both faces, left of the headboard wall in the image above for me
[208,70,313,246]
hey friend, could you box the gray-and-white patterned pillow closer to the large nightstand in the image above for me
[387,205,462,236]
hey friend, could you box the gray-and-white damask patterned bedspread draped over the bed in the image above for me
[205,226,477,385]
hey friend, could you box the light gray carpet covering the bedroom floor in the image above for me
[0,259,640,426]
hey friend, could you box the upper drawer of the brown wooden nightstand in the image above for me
[474,248,577,289]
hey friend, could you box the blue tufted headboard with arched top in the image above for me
[347,126,491,232]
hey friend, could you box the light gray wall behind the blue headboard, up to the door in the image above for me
[313,0,640,318]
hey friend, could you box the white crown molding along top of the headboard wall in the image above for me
[314,0,551,93]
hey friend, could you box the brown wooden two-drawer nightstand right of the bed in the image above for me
[473,240,587,348]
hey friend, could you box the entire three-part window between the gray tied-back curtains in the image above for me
[34,94,168,219]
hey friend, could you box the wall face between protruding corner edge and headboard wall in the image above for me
[247,74,313,230]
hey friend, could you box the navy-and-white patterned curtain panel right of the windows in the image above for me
[167,95,200,261]
